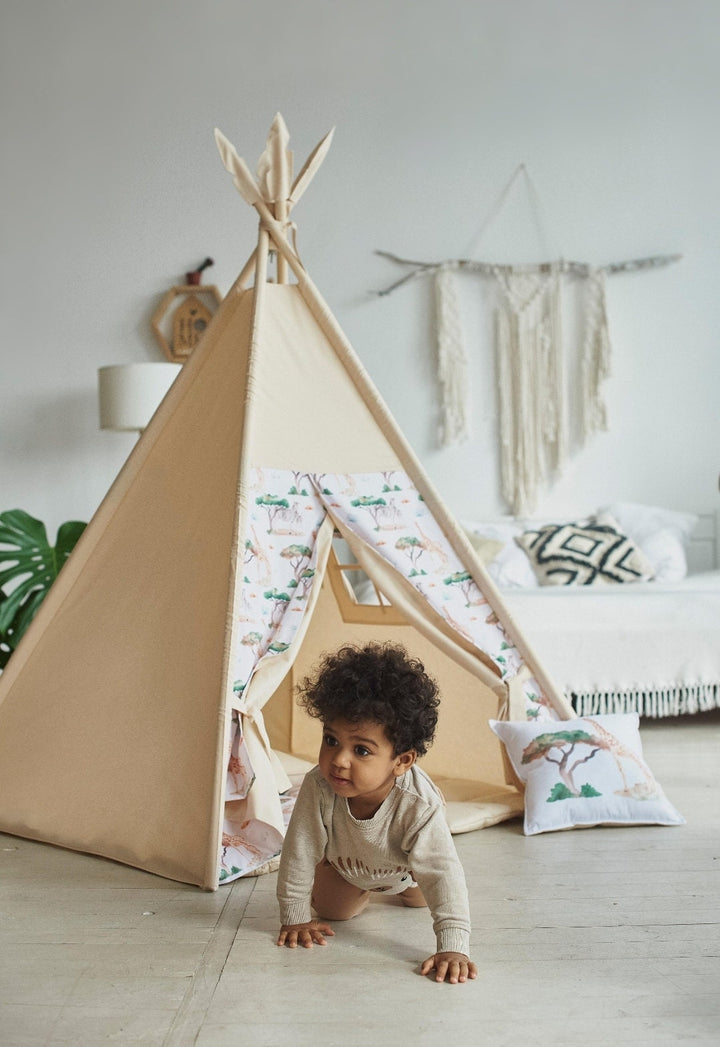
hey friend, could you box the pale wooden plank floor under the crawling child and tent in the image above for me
[0,714,720,1047]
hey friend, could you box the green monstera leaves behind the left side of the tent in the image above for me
[0,509,85,668]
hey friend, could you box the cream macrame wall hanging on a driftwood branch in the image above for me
[377,163,680,515]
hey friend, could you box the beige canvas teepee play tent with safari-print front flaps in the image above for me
[0,117,571,890]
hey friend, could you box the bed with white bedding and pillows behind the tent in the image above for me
[464,504,720,717]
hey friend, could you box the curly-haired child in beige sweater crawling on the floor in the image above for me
[277,644,477,983]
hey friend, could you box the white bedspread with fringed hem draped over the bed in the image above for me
[503,572,720,716]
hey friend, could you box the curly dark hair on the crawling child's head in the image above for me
[298,643,440,756]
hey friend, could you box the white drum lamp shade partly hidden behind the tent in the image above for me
[97,363,182,432]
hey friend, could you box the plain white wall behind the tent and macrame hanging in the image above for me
[0,0,720,529]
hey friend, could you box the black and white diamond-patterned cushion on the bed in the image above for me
[515,515,653,585]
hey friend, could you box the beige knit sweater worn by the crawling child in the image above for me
[277,764,470,955]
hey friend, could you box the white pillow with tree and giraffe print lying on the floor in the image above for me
[490,713,684,836]
